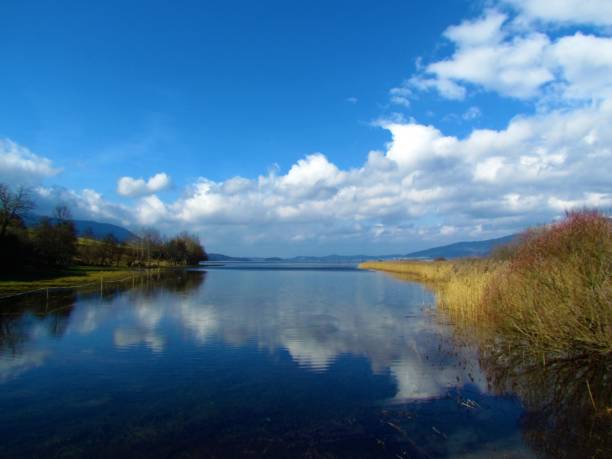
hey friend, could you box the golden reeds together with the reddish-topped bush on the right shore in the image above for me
[360,211,612,362]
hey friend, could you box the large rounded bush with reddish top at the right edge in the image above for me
[483,210,612,358]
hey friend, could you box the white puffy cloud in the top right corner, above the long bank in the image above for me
[404,5,612,101]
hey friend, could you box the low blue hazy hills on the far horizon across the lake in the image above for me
[208,234,517,263]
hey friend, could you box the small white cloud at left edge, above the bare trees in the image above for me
[0,139,60,186]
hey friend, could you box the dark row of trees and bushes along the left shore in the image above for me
[0,183,208,274]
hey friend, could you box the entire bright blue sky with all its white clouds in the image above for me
[0,0,612,256]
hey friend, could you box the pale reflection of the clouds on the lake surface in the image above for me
[47,271,486,400]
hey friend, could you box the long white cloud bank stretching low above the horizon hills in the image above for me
[39,95,612,253]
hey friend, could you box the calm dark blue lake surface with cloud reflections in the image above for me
[0,263,605,458]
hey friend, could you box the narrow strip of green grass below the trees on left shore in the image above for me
[0,266,151,297]
